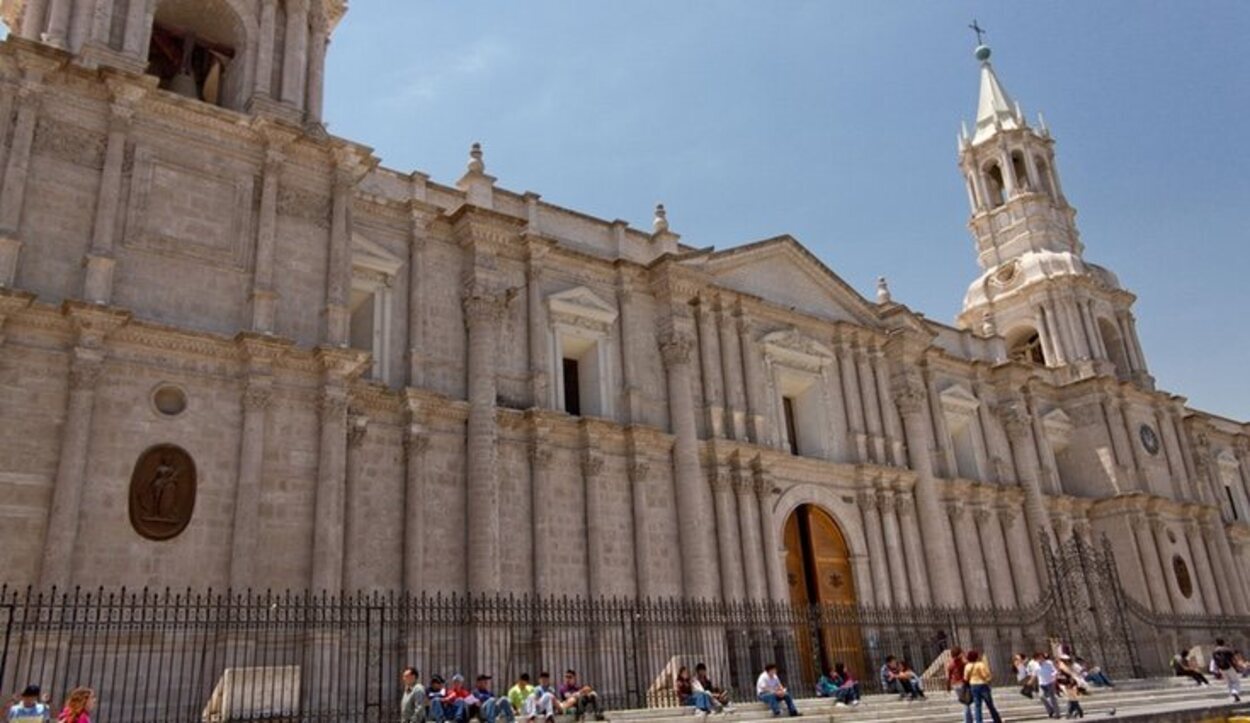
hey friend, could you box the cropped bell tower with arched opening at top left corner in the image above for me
[3,0,346,124]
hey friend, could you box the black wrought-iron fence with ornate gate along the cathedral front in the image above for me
[0,543,1250,723]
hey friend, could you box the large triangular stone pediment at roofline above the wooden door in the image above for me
[698,236,879,326]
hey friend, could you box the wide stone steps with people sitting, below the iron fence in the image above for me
[608,678,1250,723]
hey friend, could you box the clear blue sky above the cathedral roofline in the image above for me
[326,0,1250,419]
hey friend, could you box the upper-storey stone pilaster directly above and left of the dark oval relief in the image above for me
[83,90,139,304]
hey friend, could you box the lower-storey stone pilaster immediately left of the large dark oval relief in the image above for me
[39,304,130,588]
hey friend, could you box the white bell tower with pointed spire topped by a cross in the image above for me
[956,40,1154,388]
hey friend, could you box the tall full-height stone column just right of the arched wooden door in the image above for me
[891,373,964,605]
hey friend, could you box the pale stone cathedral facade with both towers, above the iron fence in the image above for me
[0,0,1250,614]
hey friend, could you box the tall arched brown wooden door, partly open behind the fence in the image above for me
[785,504,868,683]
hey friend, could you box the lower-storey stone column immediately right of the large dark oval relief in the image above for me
[230,336,286,590]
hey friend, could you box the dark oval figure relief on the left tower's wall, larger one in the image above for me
[130,444,196,540]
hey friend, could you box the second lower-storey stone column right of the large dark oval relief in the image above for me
[311,348,356,593]
